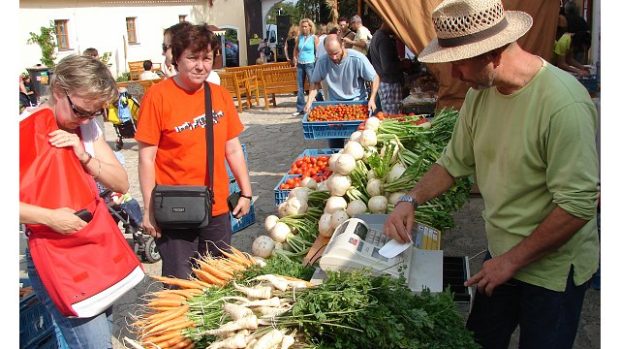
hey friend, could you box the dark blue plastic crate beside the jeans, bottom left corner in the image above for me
[19,293,68,349]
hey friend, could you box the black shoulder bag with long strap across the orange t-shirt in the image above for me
[152,82,214,230]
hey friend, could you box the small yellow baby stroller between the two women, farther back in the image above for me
[108,87,140,150]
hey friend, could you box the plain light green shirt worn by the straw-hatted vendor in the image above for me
[437,62,599,291]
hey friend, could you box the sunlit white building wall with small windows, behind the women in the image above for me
[18,0,247,76]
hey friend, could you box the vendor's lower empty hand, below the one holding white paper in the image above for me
[465,254,517,296]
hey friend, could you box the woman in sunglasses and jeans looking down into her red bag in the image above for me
[19,55,129,348]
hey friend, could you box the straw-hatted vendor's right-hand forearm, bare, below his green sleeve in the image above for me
[505,207,587,270]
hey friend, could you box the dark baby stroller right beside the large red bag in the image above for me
[99,189,161,263]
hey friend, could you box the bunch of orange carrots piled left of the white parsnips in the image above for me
[125,247,257,349]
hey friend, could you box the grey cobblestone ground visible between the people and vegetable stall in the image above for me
[89,96,600,349]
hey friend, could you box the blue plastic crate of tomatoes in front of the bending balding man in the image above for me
[301,101,368,139]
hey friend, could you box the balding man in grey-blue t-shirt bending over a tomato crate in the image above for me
[303,34,380,148]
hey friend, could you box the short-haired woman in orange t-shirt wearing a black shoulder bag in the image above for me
[135,25,252,279]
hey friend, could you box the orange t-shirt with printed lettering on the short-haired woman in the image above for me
[135,79,243,216]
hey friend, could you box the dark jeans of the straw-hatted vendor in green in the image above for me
[467,255,589,349]
